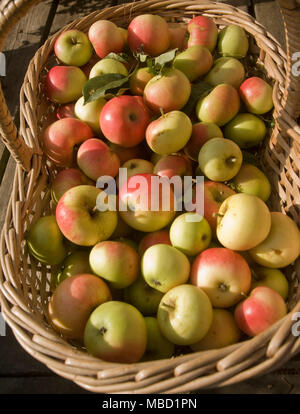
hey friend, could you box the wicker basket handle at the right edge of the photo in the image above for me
[277,0,300,119]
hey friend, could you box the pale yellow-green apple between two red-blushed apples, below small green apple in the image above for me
[141,243,190,293]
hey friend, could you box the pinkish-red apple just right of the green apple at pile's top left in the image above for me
[88,20,124,58]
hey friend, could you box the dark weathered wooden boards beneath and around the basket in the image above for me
[0,0,300,394]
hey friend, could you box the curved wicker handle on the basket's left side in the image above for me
[0,0,40,171]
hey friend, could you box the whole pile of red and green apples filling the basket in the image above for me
[27,14,300,363]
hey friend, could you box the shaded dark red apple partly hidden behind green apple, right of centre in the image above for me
[184,122,223,161]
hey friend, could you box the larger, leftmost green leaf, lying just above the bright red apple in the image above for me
[82,73,129,105]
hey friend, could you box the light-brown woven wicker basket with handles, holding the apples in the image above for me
[0,0,300,393]
